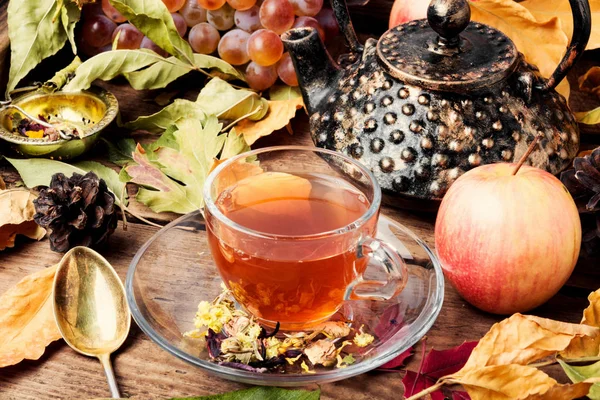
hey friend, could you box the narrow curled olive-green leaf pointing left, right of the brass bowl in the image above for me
[123,99,206,133]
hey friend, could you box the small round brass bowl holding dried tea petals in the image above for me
[0,87,119,160]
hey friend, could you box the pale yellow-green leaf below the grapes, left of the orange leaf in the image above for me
[196,78,269,121]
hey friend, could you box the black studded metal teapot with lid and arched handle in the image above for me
[282,0,591,200]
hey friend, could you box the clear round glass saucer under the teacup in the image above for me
[126,211,444,386]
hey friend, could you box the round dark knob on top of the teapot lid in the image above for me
[427,0,471,47]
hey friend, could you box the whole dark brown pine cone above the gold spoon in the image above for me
[33,172,117,252]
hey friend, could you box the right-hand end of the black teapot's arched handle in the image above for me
[544,0,592,89]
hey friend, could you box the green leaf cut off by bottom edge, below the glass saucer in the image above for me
[171,386,321,400]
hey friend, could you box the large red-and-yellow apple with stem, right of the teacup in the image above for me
[435,163,581,314]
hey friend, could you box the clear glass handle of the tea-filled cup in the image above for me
[344,238,408,300]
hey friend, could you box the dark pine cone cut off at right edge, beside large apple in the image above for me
[560,147,600,255]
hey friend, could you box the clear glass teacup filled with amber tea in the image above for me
[204,146,407,330]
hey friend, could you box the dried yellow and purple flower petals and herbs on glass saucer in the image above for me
[184,285,375,373]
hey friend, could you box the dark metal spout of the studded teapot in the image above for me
[281,28,340,115]
